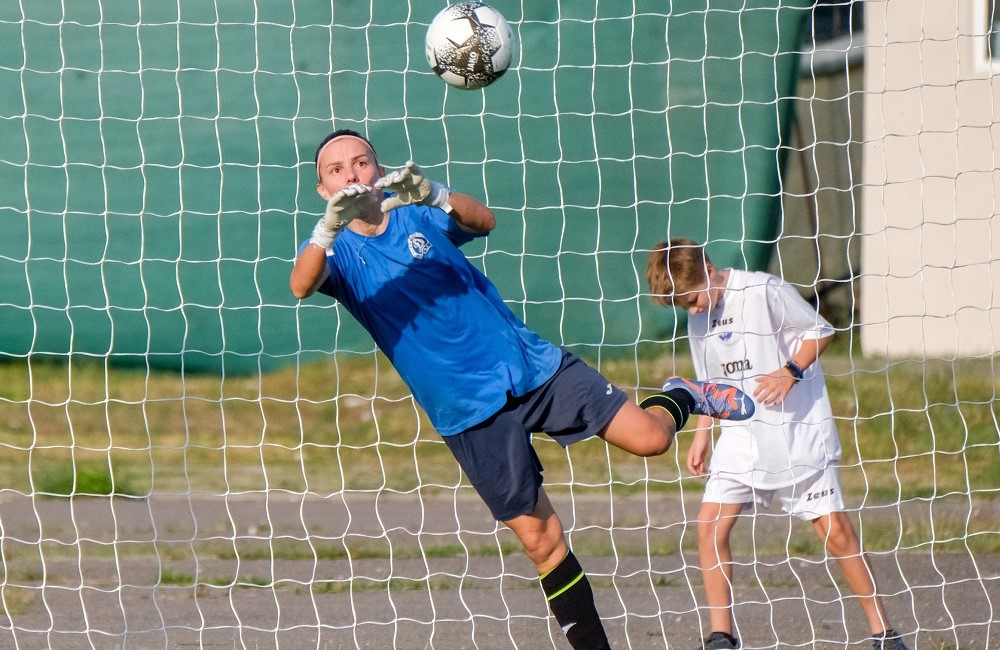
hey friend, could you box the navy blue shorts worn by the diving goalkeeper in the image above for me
[444,350,628,521]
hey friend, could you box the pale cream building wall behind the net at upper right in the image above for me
[860,0,1000,358]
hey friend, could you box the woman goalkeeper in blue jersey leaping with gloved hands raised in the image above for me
[290,130,753,648]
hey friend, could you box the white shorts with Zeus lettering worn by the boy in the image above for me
[702,465,844,521]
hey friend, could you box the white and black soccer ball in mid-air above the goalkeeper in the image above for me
[424,2,514,90]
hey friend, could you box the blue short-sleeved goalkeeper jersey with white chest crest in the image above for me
[303,205,561,436]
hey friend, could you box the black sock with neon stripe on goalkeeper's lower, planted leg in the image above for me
[541,551,611,650]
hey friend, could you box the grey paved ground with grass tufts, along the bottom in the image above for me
[0,491,1000,650]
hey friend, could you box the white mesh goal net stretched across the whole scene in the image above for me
[0,0,1000,649]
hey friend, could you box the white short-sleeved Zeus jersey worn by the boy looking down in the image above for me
[688,269,840,489]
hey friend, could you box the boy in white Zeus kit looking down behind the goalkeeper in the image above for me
[646,239,906,650]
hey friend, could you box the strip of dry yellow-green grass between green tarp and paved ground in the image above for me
[0,348,1000,503]
